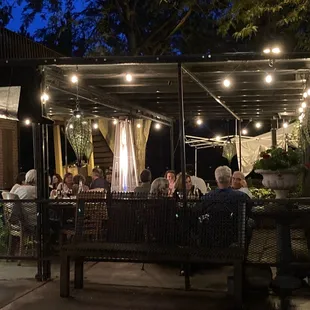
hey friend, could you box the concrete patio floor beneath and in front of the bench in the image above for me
[0,262,310,310]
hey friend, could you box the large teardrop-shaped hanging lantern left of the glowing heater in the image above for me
[66,111,92,166]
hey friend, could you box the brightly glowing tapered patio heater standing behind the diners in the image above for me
[111,120,138,192]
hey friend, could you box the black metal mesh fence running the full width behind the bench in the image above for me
[0,194,310,279]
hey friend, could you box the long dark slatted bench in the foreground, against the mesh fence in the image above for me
[60,193,245,304]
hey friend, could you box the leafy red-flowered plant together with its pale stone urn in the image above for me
[254,148,301,198]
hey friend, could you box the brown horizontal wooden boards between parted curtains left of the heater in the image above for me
[93,130,113,170]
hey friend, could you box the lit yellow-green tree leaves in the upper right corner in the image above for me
[219,0,310,51]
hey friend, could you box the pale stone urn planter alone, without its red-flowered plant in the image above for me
[255,169,298,199]
